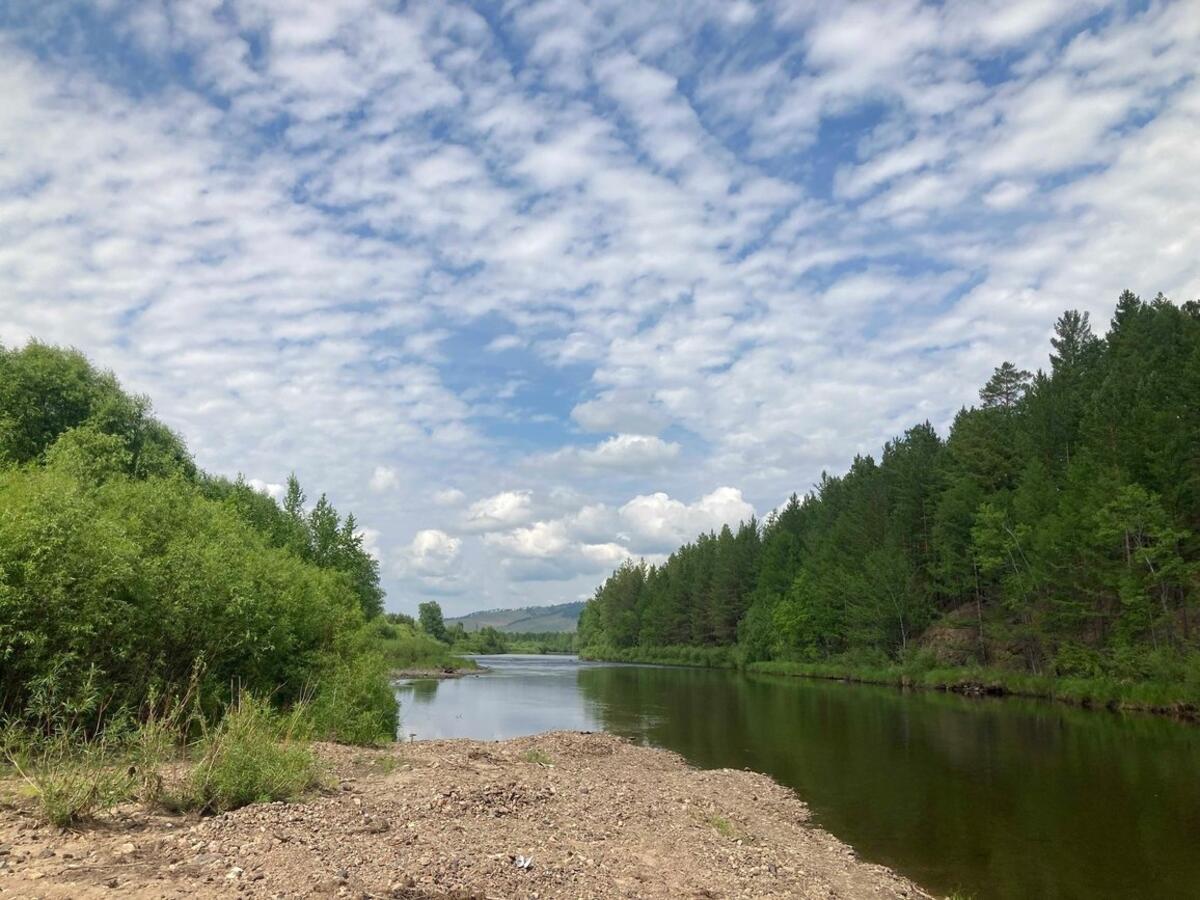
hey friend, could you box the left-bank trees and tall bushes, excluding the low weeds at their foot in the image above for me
[0,342,396,739]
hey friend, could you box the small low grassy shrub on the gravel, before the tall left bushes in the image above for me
[184,694,320,812]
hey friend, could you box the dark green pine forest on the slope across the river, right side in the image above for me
[580,292,1200,689]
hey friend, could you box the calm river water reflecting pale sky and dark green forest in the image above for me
[400,656,1200,900]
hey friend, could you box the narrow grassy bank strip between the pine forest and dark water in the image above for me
[580,648,1200,722]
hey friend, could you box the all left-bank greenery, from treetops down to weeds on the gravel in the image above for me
[0,342,408,822]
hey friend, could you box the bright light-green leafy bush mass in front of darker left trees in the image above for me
[0,467,362,727]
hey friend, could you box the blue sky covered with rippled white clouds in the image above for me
[0,0,1200,614]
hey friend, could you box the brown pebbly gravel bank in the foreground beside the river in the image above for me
[0,732,928,900]
